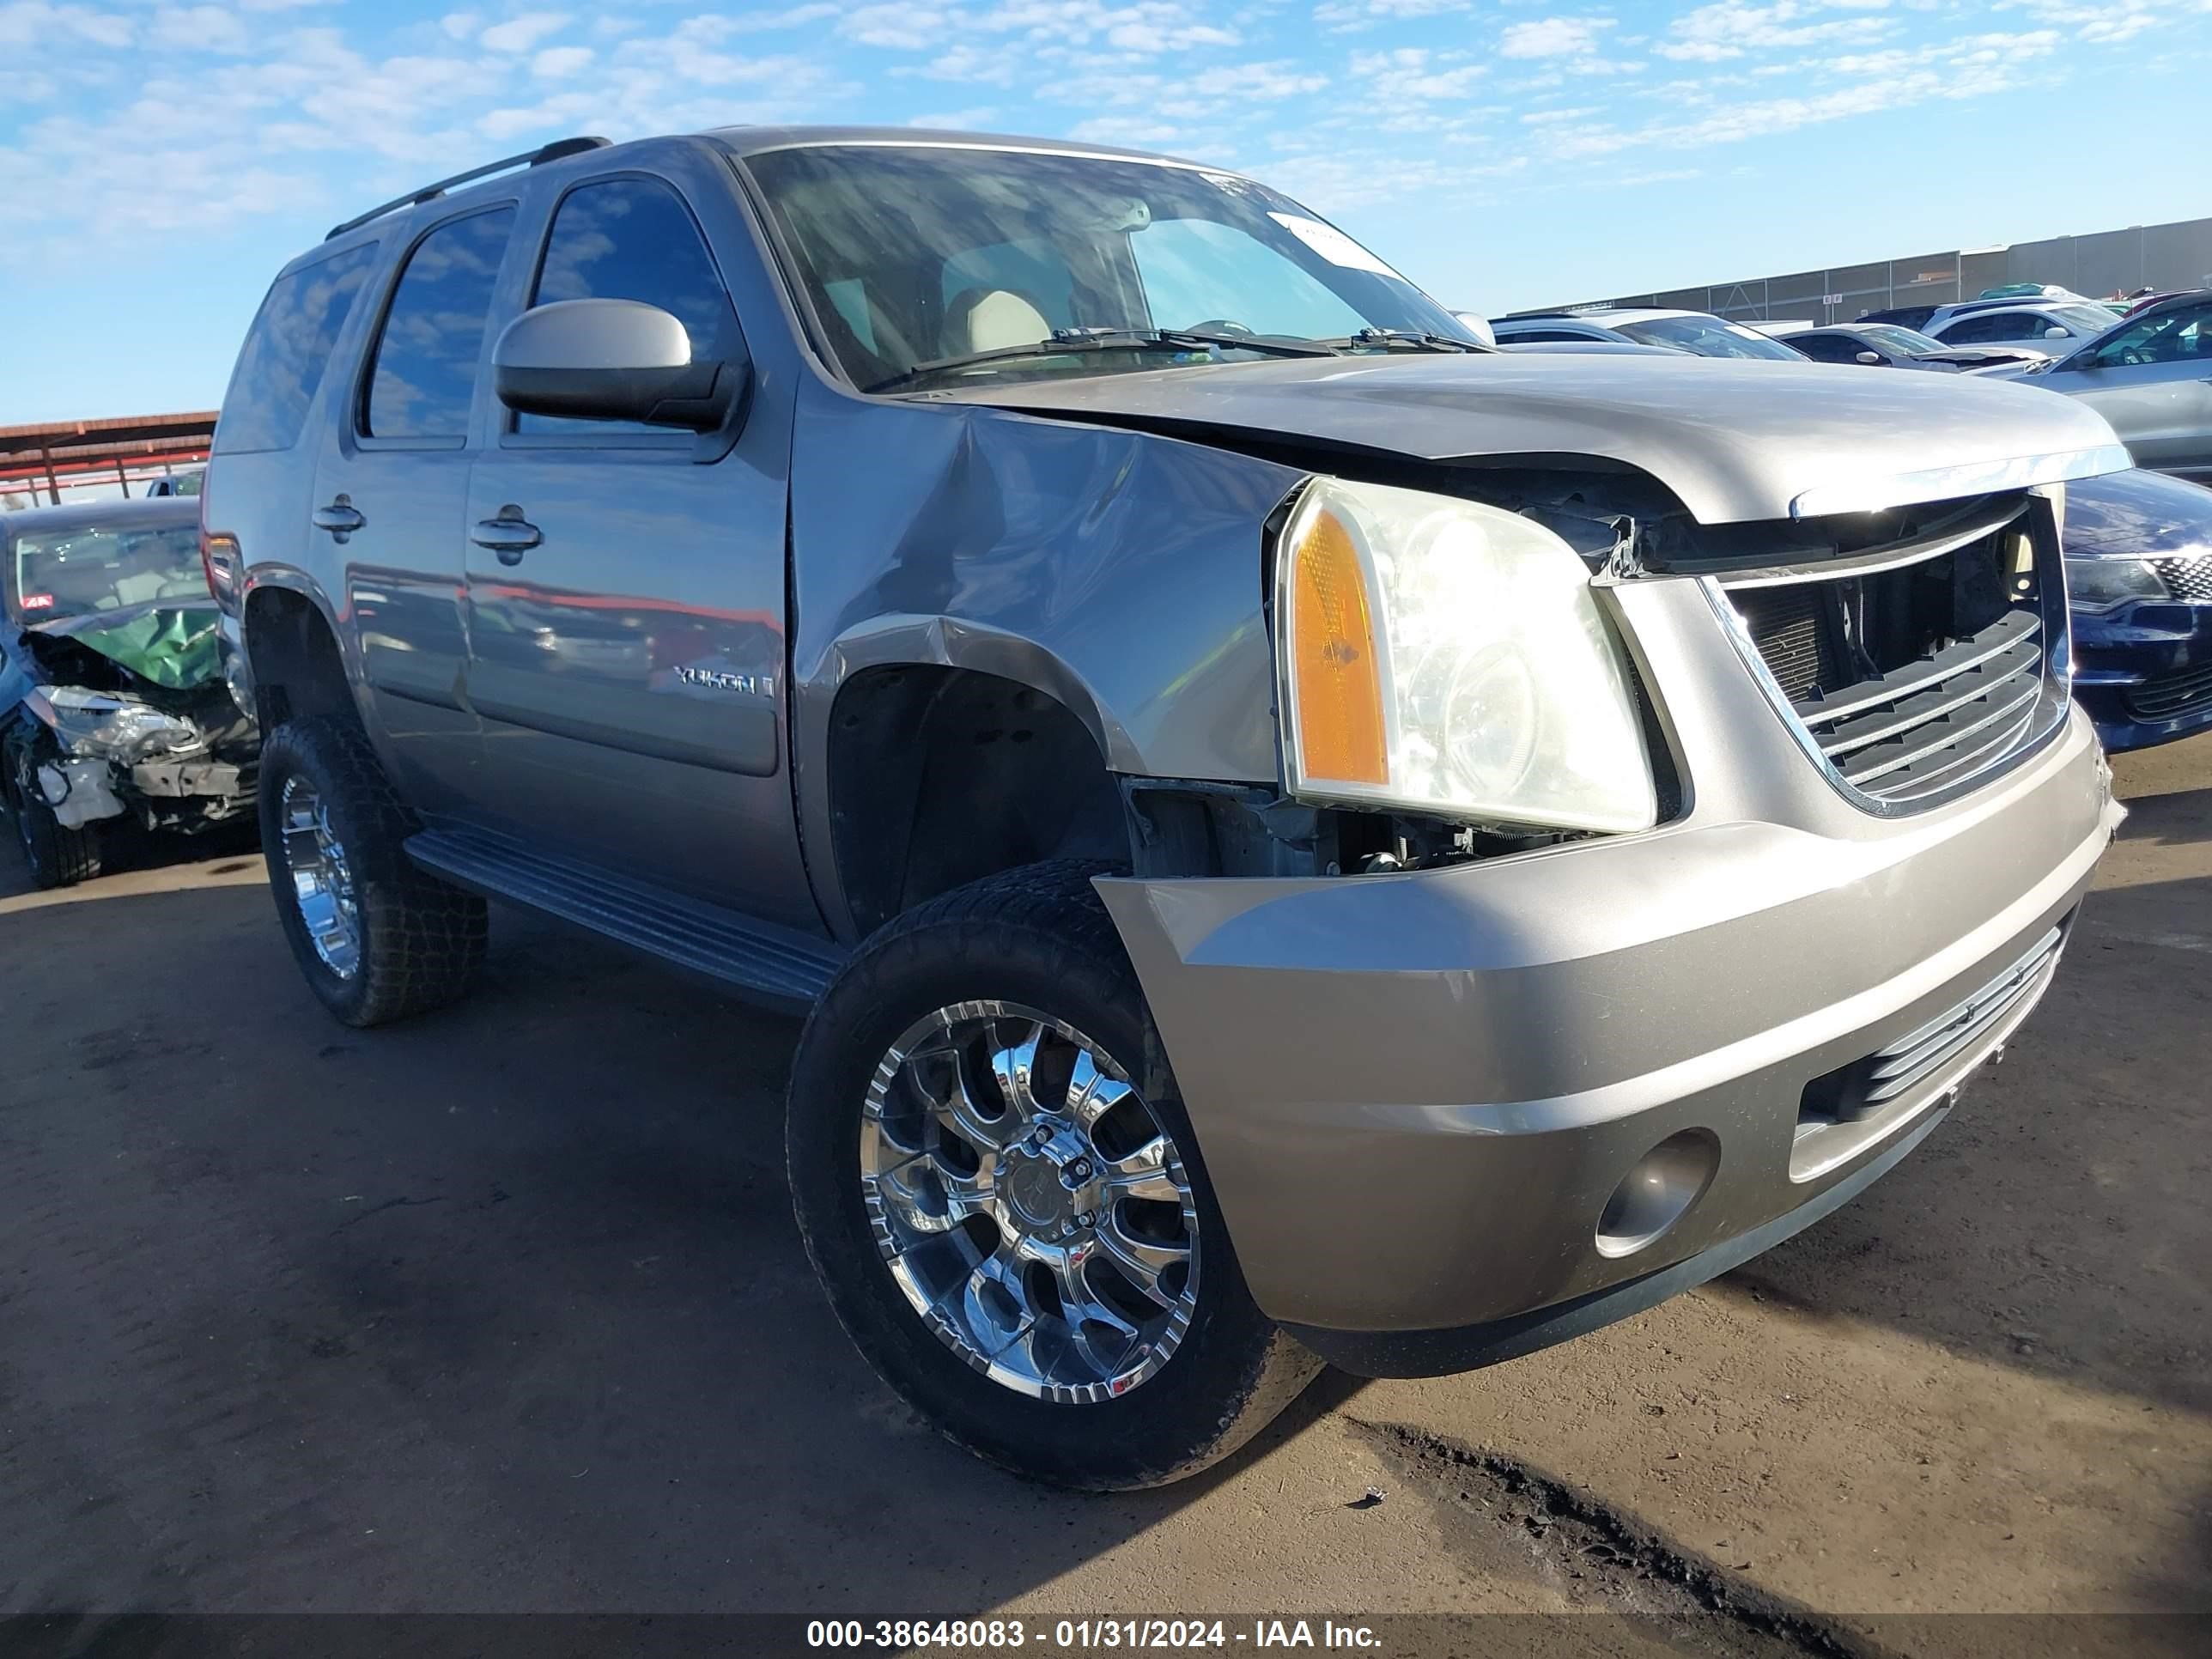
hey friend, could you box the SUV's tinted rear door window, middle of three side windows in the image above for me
[361,208,515,438]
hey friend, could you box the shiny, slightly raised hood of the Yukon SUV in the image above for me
[931,352,2130,525]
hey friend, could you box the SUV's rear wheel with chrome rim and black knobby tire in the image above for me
[258,717,489,1026]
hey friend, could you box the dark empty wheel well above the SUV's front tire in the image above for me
[830,665,1128,933]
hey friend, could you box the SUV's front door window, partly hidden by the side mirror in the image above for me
[515,179,737,431]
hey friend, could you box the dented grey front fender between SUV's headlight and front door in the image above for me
[790,383,1305,942]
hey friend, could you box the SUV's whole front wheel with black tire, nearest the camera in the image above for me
[785,863,1321,1491]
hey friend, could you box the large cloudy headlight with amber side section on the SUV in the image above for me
[1274,477,1659,832]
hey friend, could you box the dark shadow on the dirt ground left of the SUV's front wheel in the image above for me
[0,884,1356,1617]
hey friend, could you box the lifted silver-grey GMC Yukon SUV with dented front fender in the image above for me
[204,128,2128,1489]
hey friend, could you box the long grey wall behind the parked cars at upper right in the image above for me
[1557,219,2212,323]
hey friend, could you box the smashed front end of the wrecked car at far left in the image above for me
[11,606,258,832]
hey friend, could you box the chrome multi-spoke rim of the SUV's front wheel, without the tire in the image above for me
[860,1002,1199,1405]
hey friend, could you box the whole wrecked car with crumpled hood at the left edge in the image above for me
[0,498,258,887]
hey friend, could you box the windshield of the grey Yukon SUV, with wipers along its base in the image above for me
[745,143,1480,389]
